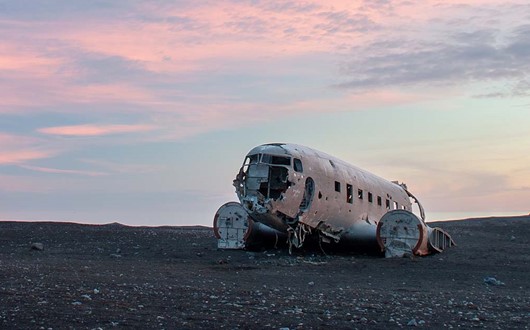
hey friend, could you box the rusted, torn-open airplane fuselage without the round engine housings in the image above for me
[234,144,412,246]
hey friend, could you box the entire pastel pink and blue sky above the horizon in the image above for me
[0,0,530,225]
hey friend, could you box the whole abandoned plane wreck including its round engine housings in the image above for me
[214,143,455,257]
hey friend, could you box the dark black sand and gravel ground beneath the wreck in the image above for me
[0,217,530,329]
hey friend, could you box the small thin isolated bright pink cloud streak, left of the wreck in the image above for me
[37,125,155,136]
